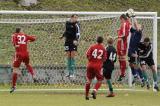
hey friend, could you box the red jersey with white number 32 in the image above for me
[12,33,35,53]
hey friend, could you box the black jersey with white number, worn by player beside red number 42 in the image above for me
[103,46,117,70]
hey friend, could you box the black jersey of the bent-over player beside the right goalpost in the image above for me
[138,42,153,59]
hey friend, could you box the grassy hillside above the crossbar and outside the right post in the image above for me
[0,0,160,64]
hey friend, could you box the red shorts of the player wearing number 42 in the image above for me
[86,65,103,81]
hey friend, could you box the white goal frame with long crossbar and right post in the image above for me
[0,10,158,91]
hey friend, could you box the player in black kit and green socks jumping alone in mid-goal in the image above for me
[60,14,80,78]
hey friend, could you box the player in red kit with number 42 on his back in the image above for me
[85,37,107,100]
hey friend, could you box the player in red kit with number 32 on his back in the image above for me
[10,28,36,93]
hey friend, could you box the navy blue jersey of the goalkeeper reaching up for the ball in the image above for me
[128,28,142,57]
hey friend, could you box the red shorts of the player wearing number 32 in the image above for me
[13,53,29,68]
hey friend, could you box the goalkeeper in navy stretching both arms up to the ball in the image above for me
[127,15,144,87]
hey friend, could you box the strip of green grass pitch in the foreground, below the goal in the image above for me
[0,91,160,106]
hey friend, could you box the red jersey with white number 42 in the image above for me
[86,44,107,65]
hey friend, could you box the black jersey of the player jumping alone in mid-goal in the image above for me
[63,21,80,43]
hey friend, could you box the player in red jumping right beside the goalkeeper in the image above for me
[117,14,131,81]
